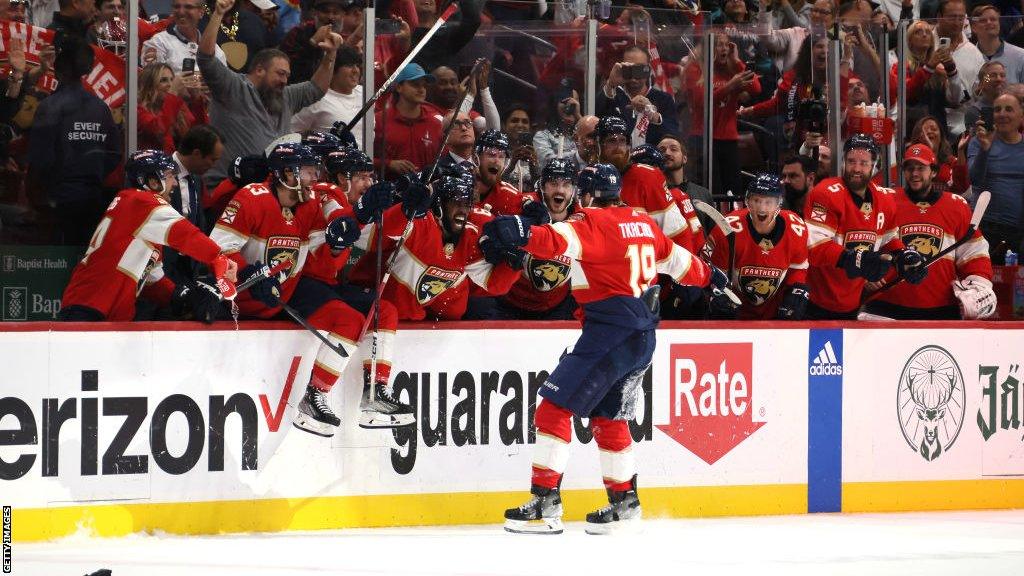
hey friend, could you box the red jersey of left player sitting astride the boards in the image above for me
[210,182,327,318]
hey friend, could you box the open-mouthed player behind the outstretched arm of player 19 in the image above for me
[495,158,579,320]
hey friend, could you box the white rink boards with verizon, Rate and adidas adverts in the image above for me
[0,323,1024,541]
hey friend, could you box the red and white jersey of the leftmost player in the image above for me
[60,189,220,322]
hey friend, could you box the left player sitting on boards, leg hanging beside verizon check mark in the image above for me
[213,143,414,437]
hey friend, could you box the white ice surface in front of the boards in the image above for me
[13,510,1024,576]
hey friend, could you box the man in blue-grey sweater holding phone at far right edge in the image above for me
[967,93,1024,258]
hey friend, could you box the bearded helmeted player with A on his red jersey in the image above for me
[804,134,928,320]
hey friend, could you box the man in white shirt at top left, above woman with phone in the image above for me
[142,0,227,74]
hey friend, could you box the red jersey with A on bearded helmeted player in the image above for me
[804,177,903,313]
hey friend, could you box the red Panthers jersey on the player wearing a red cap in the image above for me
[879,189,992,308]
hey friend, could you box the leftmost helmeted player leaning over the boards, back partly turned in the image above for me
[60,150,238,322]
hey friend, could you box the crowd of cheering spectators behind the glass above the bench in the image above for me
[0,0,1024,317]
